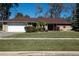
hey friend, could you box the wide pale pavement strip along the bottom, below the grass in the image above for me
[0,51,79,56]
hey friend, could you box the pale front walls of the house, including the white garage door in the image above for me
[3,24,72,32]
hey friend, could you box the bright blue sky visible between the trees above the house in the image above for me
[10,3,75,18]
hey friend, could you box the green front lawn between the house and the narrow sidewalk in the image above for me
[5,32,79,38]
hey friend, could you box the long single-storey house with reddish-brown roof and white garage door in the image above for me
[0,18,72,32]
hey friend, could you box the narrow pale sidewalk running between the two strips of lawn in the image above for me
[0,38,79,40]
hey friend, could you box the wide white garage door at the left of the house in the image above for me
[8,25,25,32]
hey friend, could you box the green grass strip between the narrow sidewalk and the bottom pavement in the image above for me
[0,40,79,51]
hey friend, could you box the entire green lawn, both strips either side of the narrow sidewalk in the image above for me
[0,32,79,51]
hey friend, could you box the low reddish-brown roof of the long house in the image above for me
[0,18,71,24]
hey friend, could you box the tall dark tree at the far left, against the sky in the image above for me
[0,3,19,20]
